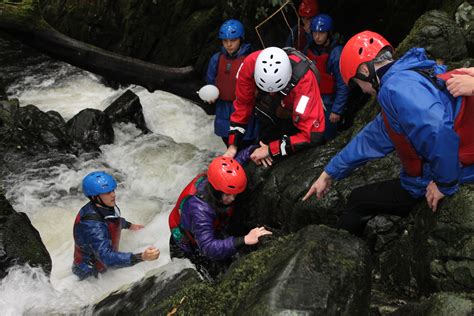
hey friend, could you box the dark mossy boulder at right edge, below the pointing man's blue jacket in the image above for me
[379,185,474,294]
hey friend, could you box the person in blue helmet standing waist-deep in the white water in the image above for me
[72,171,160,280]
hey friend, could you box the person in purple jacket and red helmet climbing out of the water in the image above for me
[169,146,271,280]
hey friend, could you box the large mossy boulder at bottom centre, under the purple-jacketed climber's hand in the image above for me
[144,226,370,315]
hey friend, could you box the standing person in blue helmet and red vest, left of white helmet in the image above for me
[206,20,259,146]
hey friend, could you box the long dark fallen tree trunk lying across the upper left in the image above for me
[0,0,210,113]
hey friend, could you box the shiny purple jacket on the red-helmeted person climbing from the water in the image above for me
[178,146,257,260]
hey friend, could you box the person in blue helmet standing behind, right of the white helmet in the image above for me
[303,14,349,140]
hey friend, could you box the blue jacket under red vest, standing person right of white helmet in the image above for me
[303,38,349,114]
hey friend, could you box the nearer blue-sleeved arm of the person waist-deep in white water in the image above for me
[79,221,132,268]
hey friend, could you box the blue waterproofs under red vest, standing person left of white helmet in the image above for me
[206,43,259,140]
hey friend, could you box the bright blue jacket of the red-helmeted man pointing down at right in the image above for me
[325,48,474,198]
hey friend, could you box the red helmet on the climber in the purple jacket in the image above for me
[207,156,247,194]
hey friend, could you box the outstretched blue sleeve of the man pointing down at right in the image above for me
[324,114,394,180]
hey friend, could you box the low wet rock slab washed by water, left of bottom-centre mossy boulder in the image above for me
[94,266,202,315]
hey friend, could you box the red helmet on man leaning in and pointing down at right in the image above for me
[339,31,393,85]
